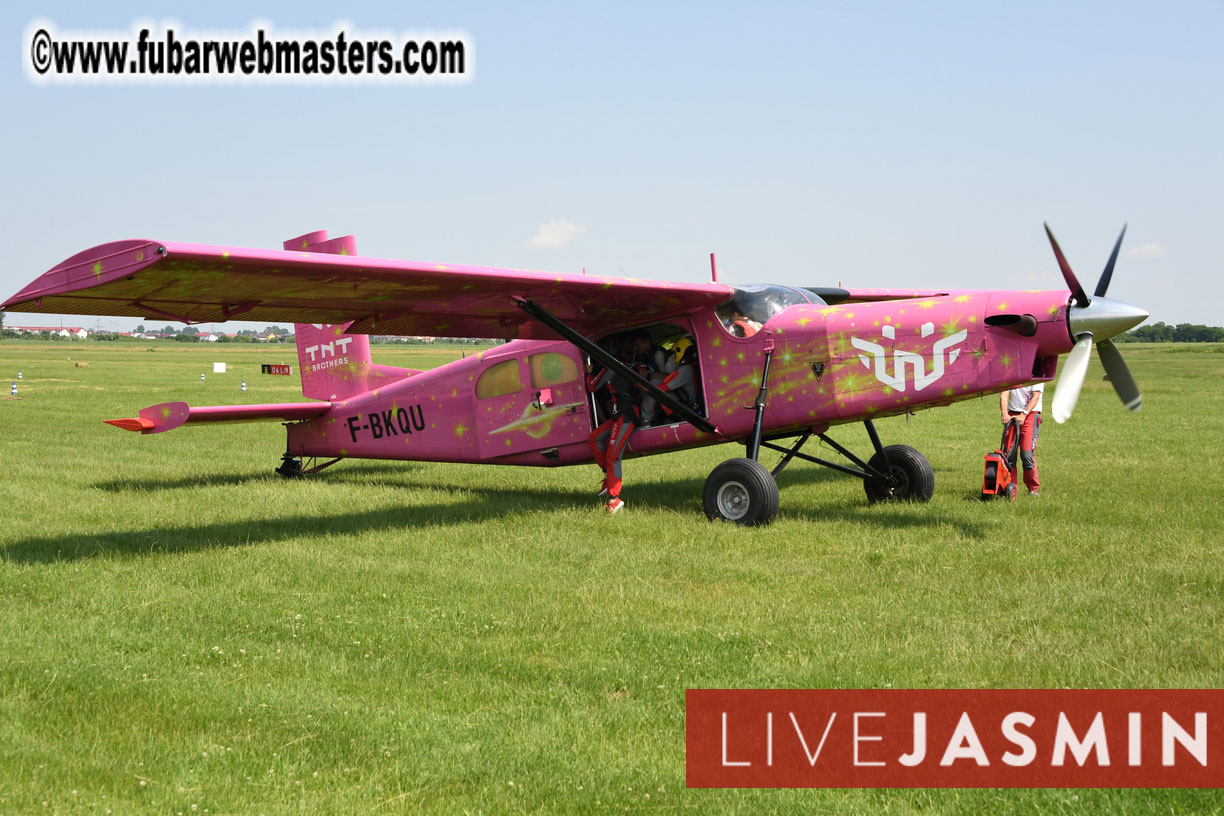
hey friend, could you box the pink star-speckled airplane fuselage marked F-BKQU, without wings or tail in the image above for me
[289,290,1073,466]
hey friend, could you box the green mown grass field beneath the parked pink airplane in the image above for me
[0,340,1224,815]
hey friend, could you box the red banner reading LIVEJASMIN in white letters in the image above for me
[685,689,1224,788]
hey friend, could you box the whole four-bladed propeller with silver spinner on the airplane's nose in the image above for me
[1045,224,1148,423]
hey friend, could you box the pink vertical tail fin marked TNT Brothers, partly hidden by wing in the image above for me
[284,231,420,400]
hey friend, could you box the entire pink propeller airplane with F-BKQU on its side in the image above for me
[4,228,1147,525]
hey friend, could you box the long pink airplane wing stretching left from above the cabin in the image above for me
[2,240,732,339]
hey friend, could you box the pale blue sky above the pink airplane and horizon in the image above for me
[0,1,1224,328]
